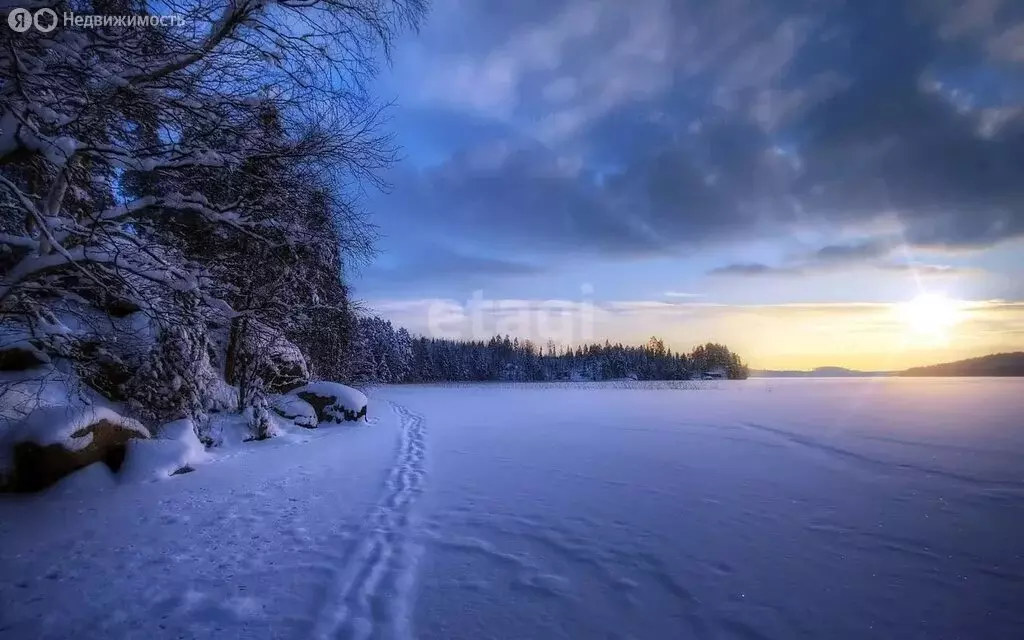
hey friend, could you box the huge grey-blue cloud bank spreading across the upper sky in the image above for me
[385,0,1024,264]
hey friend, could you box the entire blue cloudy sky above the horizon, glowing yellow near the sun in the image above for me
[355,0,1024,367]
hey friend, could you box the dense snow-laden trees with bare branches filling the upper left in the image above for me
[0,0,424,411]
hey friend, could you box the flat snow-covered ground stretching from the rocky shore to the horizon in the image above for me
[0,379,1024,640]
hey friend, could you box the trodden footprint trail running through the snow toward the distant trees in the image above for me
[312,404,426,640]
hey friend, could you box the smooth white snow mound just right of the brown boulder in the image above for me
[119,418,207,482]
